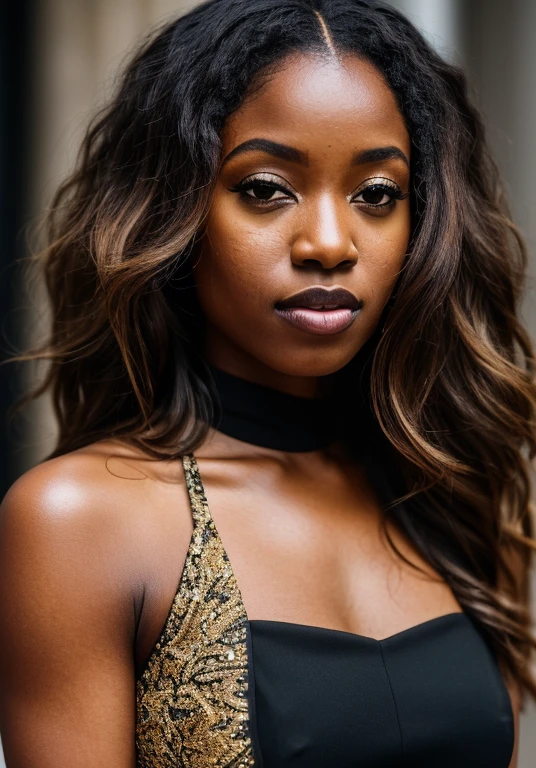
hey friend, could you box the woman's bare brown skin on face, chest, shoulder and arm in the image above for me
[0,56,519,768]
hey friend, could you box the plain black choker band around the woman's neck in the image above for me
[209,364,336,451]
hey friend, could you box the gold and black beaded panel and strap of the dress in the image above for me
[136,454,255,768]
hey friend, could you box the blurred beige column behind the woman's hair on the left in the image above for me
[21,0,154,470]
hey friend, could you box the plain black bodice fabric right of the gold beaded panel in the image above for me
[248,613,514,768]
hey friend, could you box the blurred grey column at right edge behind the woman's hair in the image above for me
[464,0,536,328]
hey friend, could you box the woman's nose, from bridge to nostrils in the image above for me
[296,193,356,268]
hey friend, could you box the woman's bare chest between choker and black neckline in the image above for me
[138,452,460,661]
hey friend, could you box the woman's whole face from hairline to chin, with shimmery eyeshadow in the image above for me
[194,54,410,395]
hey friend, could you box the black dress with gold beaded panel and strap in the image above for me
[136,368,514,768]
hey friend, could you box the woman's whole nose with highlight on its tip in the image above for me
[290,196,358,269]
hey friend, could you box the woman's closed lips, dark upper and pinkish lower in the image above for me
[274,286,363,336]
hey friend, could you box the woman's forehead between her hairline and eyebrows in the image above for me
[222,54,410,157]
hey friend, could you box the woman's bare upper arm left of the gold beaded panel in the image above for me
[0,465,135,768]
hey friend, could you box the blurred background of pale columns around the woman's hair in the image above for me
[0,0,536,768]
